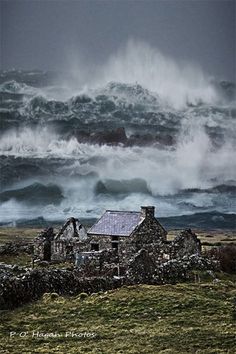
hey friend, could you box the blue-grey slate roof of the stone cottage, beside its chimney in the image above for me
[88,210,143,236]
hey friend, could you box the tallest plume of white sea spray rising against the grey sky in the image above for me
[66,40,218,109]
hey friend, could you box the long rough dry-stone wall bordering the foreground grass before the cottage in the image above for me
[0,250,218,310]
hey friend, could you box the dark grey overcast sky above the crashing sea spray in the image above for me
[0,0,236,79]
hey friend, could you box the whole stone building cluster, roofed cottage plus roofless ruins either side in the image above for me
[35,206,201,273]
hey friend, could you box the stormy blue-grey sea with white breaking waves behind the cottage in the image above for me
[0,43,236,230]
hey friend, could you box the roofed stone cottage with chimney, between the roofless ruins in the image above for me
[88,206,167,260]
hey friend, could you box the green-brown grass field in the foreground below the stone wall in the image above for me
[0,281,236,354]
